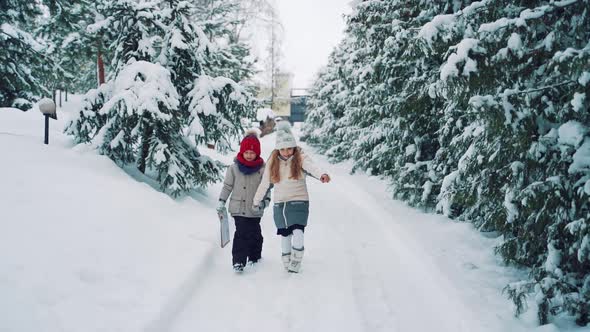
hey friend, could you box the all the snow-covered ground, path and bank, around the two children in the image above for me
[0,98,583,332]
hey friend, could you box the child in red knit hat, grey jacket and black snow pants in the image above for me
[217,131,270,272]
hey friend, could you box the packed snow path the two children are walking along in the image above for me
[155,132,528,332]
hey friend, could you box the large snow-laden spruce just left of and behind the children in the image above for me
[68,0,251,196]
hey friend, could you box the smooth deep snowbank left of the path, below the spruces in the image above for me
[0,103,218,332]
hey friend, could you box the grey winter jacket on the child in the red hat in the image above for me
[219,163,270,218]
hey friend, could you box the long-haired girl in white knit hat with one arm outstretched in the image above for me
[253,121,330,273]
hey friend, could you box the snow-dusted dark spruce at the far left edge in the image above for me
[0,1,50,110]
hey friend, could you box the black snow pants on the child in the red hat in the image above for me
[232,216,263,265]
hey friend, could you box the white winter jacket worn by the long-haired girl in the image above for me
[253,150,325,205]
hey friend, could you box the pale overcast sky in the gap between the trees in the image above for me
[275,0,351,88]
